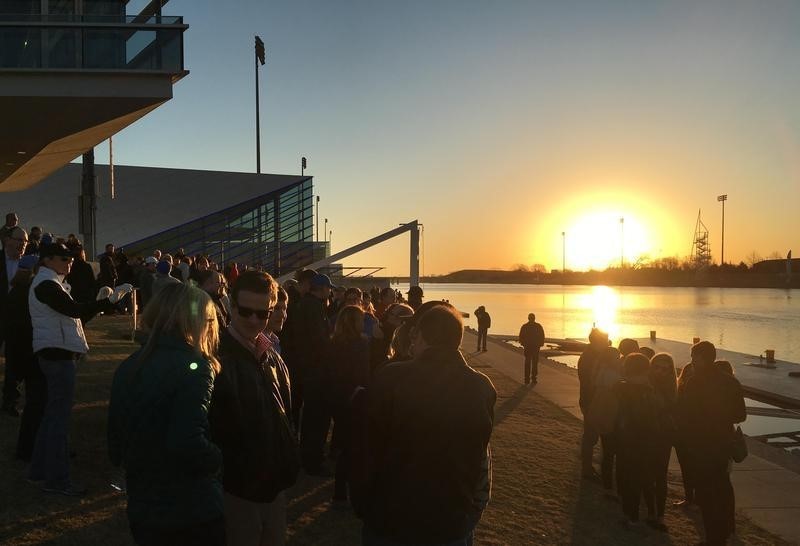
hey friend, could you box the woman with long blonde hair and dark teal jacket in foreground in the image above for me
[108,283,225,546]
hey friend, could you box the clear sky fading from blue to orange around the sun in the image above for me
[96,0,800,275]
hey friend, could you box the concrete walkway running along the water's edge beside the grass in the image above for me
[463,330,800,544]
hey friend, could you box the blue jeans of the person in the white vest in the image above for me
[30,357,76,487]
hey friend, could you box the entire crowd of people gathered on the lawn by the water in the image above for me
[0,208,745,545]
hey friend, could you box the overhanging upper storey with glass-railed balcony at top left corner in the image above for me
[0,0,188,192]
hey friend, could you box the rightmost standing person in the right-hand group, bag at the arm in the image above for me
[676,341,747,546]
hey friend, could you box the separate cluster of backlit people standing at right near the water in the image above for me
[578,329,746,545]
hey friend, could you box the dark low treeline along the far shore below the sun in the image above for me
[416,260,800,288]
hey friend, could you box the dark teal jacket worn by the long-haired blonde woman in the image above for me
[108,336,222,529]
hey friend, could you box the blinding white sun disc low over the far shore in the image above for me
[565,210,652,270]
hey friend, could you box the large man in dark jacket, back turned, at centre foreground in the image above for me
[362,304,497,546]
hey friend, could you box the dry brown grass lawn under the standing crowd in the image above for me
[0,317,785,546]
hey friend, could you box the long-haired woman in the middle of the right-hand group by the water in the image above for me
[648,353,678,531]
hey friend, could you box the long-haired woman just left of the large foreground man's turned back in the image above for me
[328,305,370,504]
